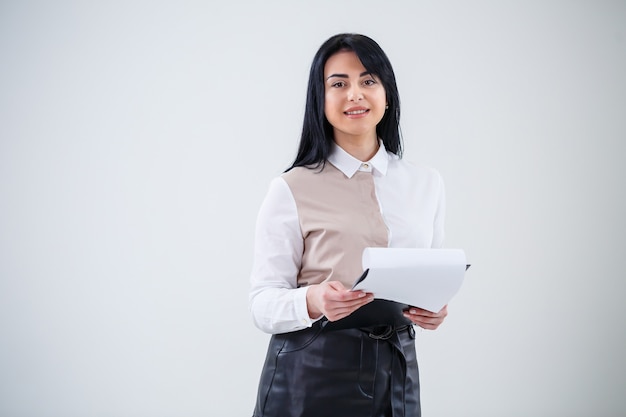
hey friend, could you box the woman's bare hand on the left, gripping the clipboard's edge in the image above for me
[306,281,374,321]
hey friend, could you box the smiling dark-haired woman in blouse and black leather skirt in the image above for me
[250,34,447,417]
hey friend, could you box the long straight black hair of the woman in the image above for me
[288,33,402,170]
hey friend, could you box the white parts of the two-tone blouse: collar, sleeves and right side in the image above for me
[249,143,445,333]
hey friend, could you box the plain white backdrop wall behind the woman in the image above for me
[0,0,626,417]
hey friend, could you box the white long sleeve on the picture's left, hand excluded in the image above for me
[249,177,312,333]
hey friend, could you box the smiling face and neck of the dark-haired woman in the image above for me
[324,50,387,145]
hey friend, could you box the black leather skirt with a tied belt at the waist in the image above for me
[254,322,421,417]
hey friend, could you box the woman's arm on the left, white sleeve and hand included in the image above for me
[250,178,373,333]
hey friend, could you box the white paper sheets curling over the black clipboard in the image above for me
[353,248,467,312]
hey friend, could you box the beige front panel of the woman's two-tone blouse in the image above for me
[283,162,388,288]
